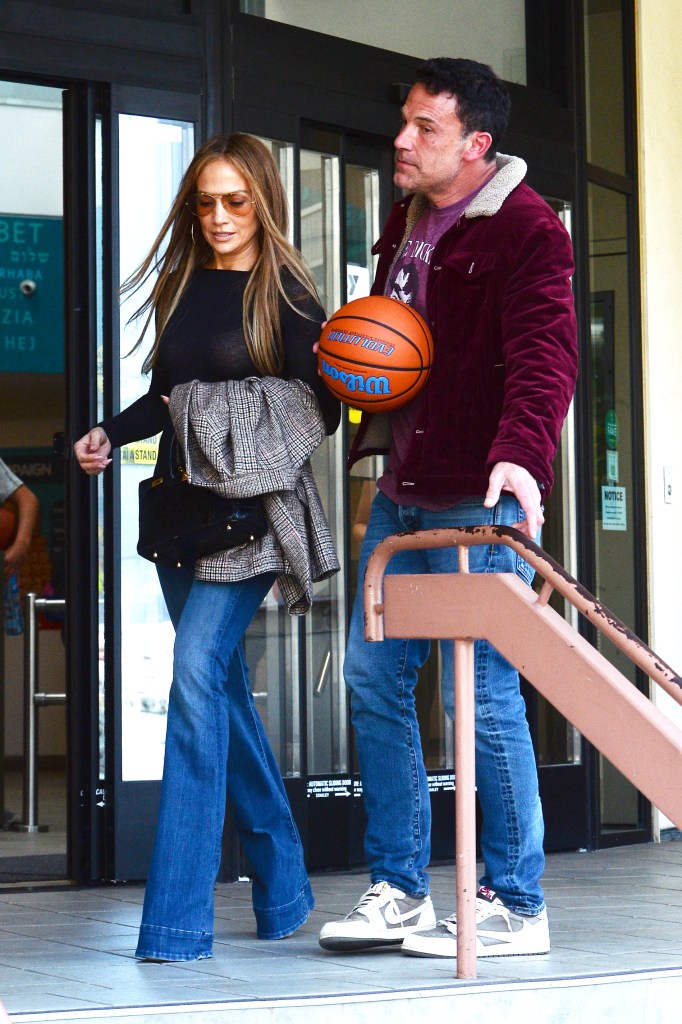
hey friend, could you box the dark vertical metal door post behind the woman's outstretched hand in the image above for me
[63,79,102,885]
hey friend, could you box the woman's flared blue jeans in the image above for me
[135,569,313,961]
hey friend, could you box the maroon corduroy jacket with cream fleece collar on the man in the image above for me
[349,154,578,504]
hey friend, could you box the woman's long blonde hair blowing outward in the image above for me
[121,132,317,375]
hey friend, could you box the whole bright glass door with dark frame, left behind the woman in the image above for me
[103,89,199,879]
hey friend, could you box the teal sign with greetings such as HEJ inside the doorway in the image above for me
[0,214,63,374]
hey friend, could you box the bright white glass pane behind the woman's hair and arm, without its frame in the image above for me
[119,115,194,781]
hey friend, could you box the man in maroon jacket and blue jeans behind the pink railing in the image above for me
[319,57,577,956]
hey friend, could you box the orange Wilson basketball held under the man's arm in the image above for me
[317,295,433,413]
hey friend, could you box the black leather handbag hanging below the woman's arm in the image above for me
[137,444,267,568]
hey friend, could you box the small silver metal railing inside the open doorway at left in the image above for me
[17,594,67,833]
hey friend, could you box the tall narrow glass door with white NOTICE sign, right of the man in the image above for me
[583,0,651,846]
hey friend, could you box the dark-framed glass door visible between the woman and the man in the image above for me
[299,127,392,868]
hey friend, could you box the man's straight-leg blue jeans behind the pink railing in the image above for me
[344,493,545,914]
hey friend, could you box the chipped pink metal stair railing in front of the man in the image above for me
[364,526,682,978]
